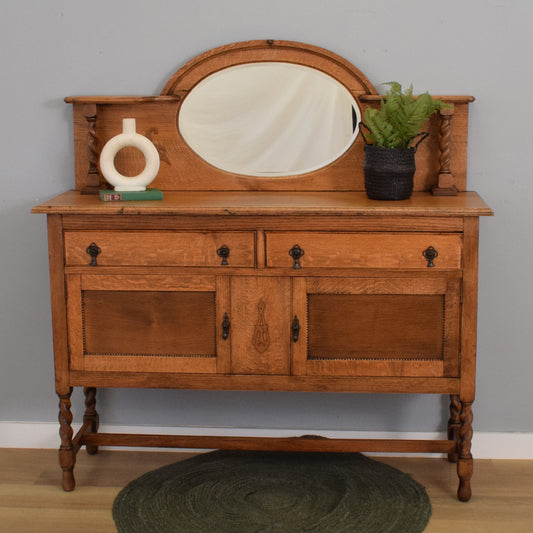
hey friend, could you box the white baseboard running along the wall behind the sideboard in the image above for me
[0,422,533,459]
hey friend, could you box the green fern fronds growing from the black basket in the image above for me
[364,81,451,148]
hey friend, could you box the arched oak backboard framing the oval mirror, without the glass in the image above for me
[66,40,473,194]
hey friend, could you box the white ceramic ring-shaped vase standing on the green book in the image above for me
[100,118,159,191]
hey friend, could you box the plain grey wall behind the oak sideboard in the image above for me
[0,0,533,432]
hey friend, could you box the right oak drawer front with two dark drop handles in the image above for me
[266,232,462,269]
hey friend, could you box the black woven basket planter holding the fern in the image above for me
[363,144,416,200]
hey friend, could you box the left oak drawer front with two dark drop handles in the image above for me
[65,231,255,267]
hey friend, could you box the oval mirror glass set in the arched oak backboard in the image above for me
[178,62,360,177]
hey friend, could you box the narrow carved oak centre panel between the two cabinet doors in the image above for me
[229,276,291,375]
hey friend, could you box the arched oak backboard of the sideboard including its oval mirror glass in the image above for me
[67,40,472,193]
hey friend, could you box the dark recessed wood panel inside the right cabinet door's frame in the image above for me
[308,294,444,360]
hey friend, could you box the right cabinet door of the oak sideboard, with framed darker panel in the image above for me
[293,274,460,377]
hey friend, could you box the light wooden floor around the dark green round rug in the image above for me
[0,449,533,533]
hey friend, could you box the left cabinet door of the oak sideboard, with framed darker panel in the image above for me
[67,274,229,373]
